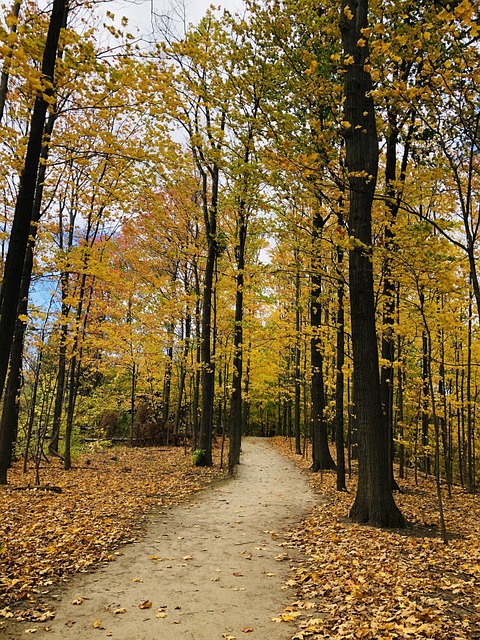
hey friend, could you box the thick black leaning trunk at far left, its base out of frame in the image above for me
[0,0,67,398]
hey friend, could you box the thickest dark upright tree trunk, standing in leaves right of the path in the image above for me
[340,0,405,527]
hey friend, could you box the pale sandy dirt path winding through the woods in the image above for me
[7,438,317,640]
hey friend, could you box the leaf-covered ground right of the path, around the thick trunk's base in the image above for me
[274,438,480,640]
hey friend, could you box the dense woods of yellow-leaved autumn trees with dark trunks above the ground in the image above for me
[0,0,480,526]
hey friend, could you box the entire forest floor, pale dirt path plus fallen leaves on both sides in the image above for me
[0,438,480,640]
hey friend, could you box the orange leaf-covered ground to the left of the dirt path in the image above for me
[0,448,222,629]
